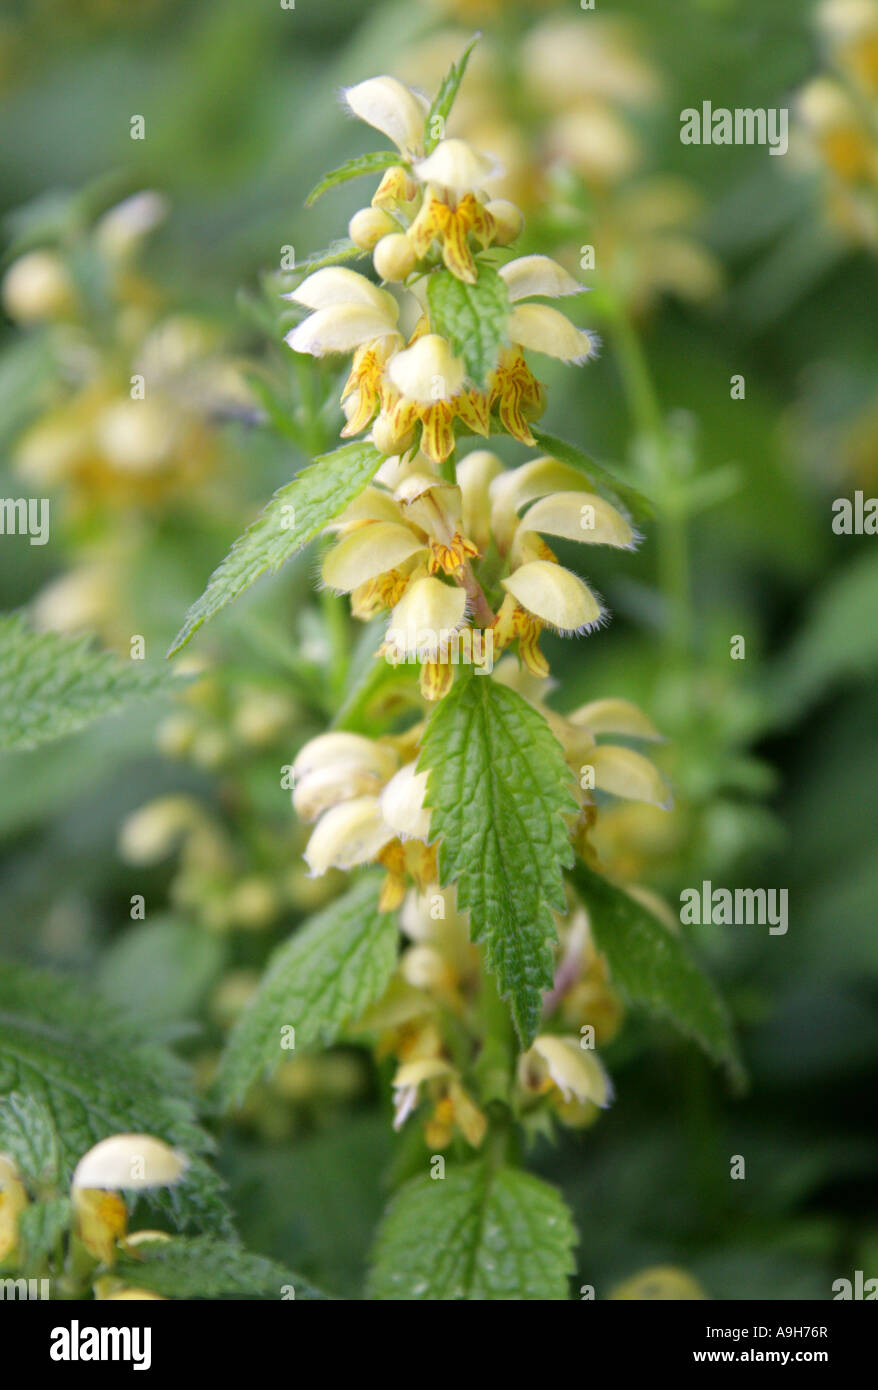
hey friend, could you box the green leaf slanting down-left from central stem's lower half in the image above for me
[215,874,397,1105]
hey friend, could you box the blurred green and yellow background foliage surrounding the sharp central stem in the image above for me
[0,0,878,1298]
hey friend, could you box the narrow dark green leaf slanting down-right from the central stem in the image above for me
[572,863,745,1087]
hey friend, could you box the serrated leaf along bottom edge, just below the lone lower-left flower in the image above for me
[113,1236,326,1300]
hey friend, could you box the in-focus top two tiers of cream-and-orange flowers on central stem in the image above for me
[288,76,597,464]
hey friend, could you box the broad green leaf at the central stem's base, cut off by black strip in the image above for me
[368,1162,577,1301]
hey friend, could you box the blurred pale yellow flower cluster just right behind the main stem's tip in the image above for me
[400,17,720,314]
